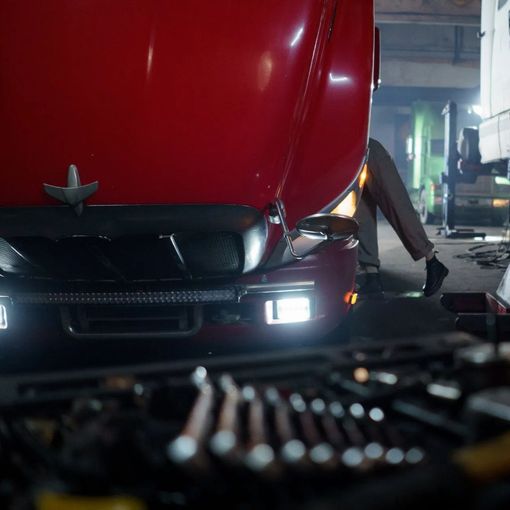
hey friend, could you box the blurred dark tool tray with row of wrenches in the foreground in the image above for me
[0,333,510,510]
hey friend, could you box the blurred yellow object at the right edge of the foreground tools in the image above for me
[453,432,510,483]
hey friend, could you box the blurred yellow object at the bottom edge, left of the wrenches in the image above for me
[36,491,148,510]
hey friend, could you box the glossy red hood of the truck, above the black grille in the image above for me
[0,0,372,228]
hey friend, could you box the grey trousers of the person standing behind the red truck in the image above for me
[354,138,434,267]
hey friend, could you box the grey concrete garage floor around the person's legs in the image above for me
[352,221,508,341]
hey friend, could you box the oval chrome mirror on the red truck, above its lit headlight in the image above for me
[296,214,359,241]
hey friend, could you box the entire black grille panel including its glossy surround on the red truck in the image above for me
[0,204,268,282]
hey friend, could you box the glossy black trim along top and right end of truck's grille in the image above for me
[0,204,268,272]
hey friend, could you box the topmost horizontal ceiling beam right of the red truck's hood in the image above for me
[375,0,481,26]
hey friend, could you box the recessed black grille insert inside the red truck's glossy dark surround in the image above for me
[0,232,244,282]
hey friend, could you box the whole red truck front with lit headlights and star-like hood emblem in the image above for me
[0,0,378,356]
